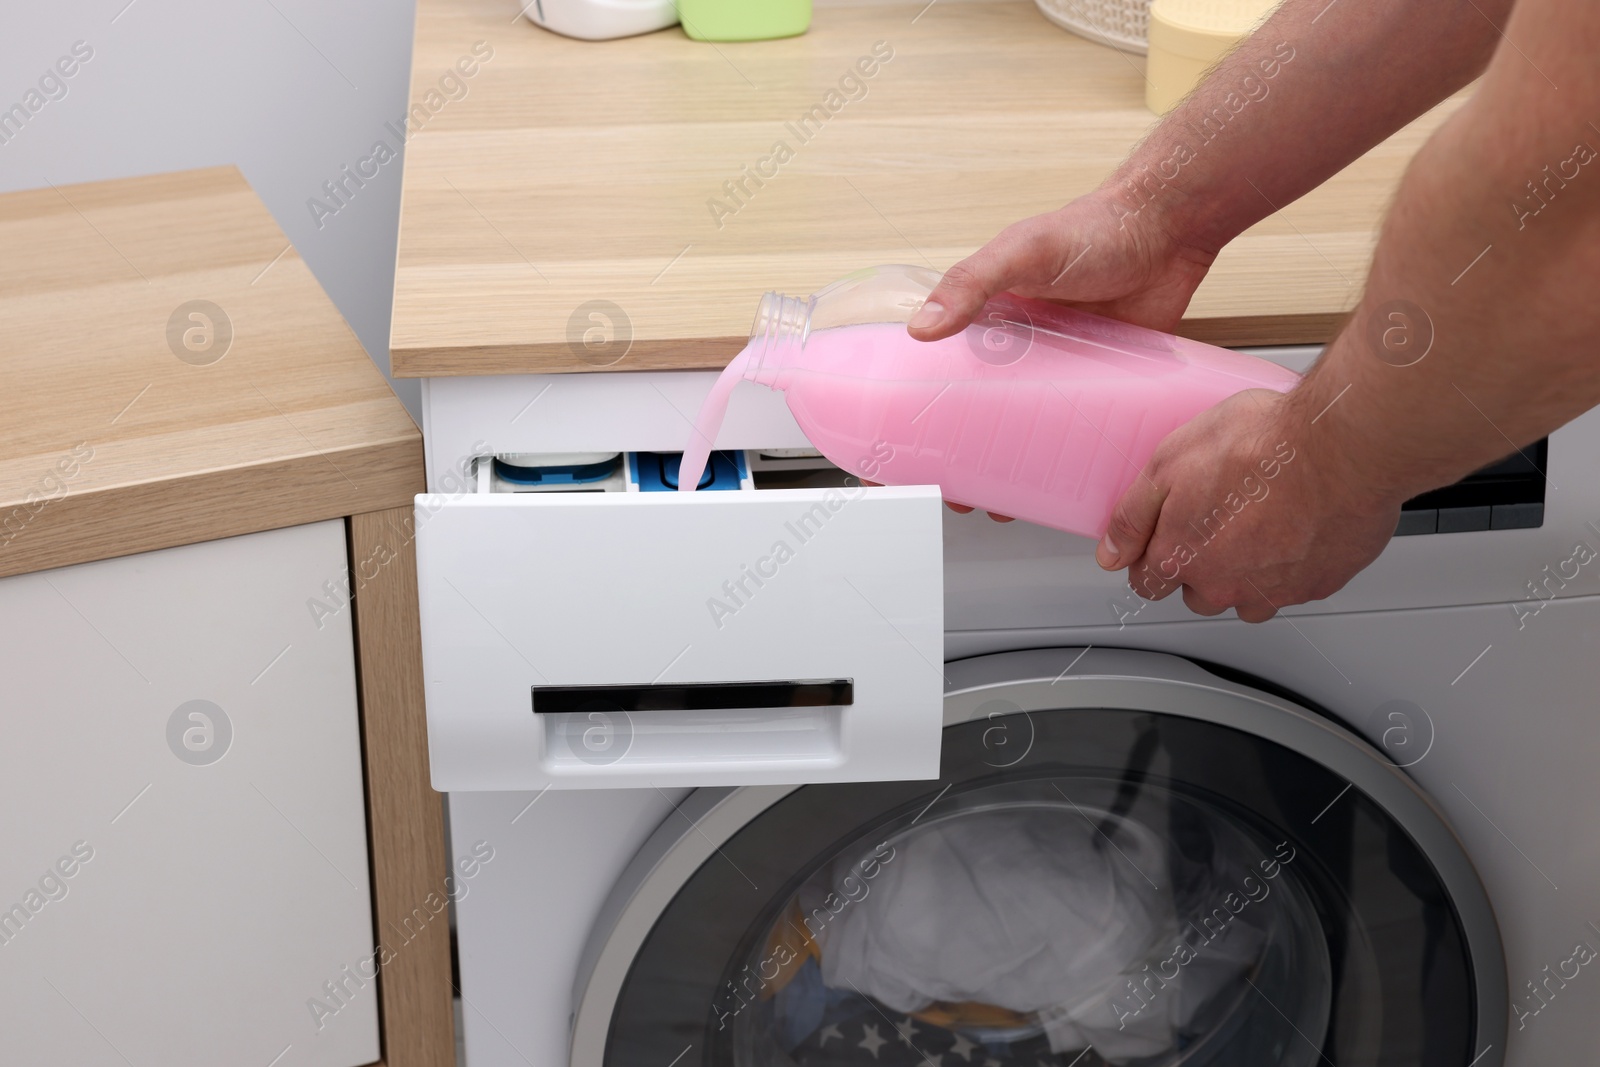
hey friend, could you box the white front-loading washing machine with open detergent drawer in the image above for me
[416,349,1600,1067]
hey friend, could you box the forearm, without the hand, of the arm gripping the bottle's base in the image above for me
[1291,0,1600,507]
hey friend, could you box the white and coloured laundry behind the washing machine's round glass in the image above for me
[712,782,1326,1067]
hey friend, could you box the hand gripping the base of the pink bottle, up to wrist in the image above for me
[1094,389,1400,622]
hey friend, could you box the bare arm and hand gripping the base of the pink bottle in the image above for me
[1096,0,1600,622]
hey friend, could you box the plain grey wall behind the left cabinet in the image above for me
[0,0,418,418]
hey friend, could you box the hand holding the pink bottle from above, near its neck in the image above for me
[907,189,1216,341]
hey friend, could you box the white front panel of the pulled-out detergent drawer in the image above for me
[416,485,944,790]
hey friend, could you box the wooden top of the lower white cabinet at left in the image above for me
[0,166,422,574]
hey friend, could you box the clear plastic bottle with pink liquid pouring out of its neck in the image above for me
[678,266,1299,537]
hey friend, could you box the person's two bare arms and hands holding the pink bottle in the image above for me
[910,0,1600,601]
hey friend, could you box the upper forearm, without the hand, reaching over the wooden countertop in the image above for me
[1104,0,1510,254]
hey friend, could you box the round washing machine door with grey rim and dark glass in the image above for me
[571,649,1506,1067]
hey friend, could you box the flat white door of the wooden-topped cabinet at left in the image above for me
[0,522,377,1067]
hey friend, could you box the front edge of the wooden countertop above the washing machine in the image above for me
[389,312,1347,378]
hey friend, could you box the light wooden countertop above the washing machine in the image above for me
[390,0,1459,378]
